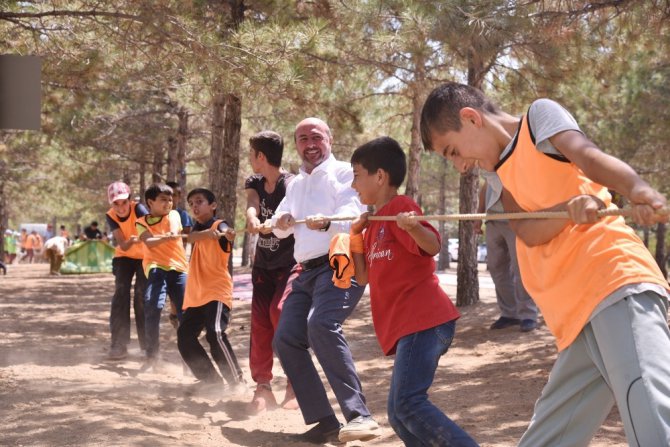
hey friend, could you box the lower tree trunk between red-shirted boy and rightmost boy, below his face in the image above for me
[456,169,479,306]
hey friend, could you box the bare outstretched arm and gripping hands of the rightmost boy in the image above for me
[549,130,668,225]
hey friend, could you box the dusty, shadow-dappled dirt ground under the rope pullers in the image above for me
[0,264,626,447]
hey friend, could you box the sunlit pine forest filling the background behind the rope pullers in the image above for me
[0,0,670,304]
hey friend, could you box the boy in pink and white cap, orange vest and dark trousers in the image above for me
[106,182,149,360]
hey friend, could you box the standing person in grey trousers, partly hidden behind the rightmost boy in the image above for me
[475,176,537,332]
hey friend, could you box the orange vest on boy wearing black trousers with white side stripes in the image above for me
[183,220,233,310]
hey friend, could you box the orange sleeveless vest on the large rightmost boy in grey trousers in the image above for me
[496,116,668,351]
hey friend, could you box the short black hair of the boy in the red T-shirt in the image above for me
[351,137,407,188]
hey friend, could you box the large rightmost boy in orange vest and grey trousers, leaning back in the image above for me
[421,83,670,446]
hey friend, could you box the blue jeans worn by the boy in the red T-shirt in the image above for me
[388,321,477,447]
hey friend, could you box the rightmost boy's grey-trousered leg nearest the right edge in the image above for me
[591,292,670,446]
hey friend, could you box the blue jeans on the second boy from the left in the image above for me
[144,268,186,357]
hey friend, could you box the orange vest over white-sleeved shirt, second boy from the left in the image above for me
[137,210,188,277]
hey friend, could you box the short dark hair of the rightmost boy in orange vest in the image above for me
[421,82,500,151]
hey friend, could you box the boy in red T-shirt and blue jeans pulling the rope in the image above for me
[350,137,477,446]
